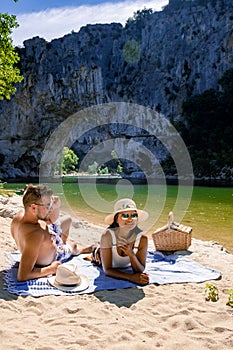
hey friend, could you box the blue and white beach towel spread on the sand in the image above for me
[4,251,221,297]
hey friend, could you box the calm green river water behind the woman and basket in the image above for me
[6,182,233,253]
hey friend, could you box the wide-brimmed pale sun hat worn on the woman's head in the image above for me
[104,198,149,225]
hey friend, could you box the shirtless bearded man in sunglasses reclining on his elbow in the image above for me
[11,185,91,282]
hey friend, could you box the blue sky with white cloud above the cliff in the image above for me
[0,0,168,46]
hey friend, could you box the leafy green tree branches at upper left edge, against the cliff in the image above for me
[0,0,23,100]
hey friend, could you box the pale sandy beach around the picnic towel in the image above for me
[0,196,233,350]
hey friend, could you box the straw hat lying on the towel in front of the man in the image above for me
[48,263,89,292]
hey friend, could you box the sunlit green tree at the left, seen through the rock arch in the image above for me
[55,147,79,174]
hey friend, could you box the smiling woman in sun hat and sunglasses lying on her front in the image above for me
[93,198,149,285]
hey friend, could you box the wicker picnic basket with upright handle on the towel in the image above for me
[152,212,192,252]
